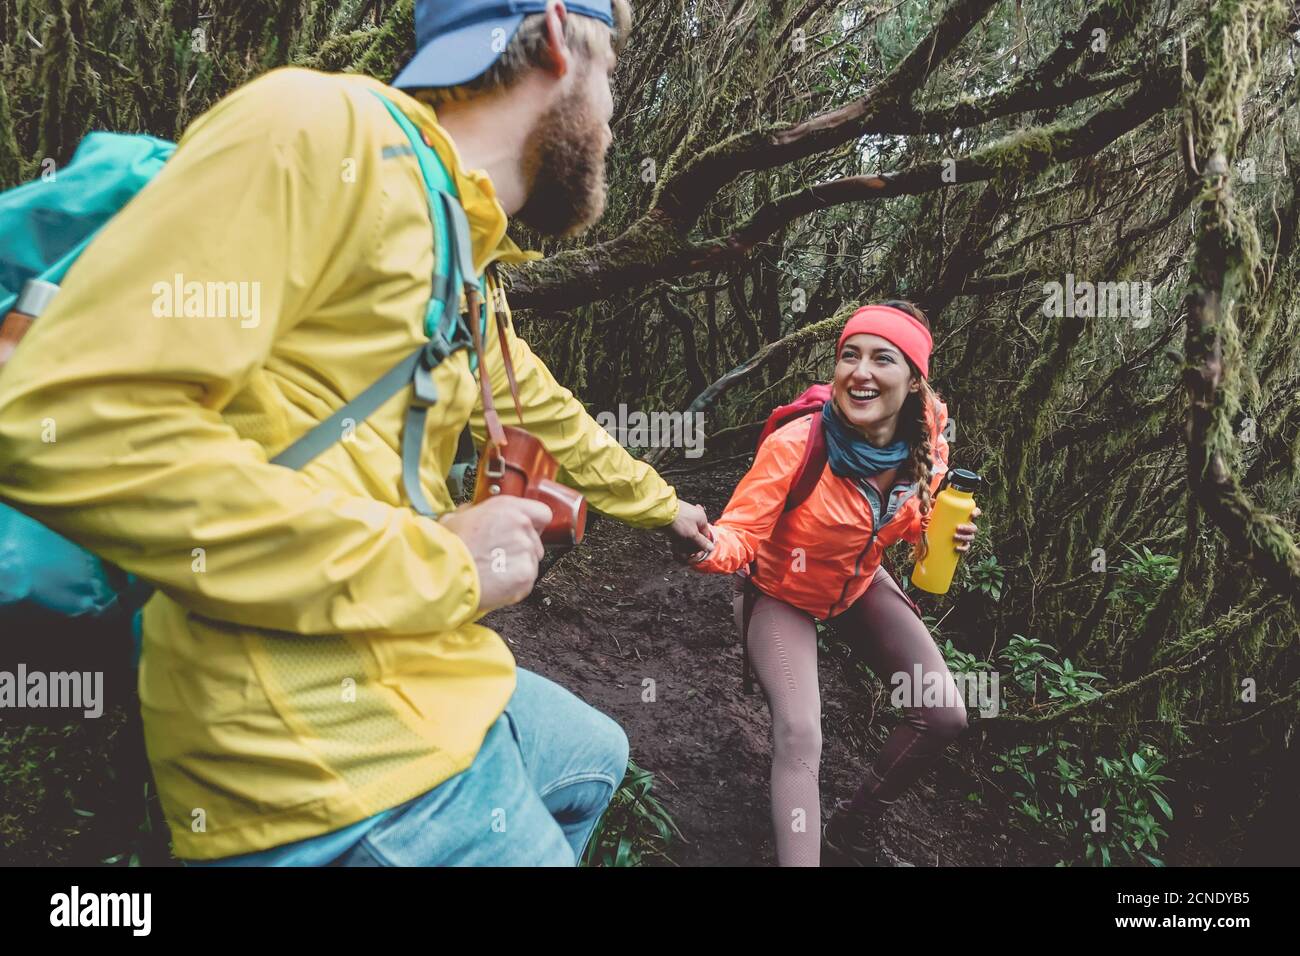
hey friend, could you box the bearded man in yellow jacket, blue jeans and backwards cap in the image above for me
[0,0,707,865]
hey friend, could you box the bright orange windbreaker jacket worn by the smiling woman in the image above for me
[692,398,948,619]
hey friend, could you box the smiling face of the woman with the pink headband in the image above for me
[831,332,920,446]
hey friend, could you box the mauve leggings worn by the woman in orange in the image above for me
[733,567,966,866]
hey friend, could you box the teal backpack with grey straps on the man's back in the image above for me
[0,92,486,663]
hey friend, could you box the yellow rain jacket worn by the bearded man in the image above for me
[0,69,679,860]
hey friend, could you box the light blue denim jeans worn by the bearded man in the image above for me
[185,667,628,866]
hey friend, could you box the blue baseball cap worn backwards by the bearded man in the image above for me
[393,0,614,88]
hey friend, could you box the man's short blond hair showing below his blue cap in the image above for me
[407,0,632,108]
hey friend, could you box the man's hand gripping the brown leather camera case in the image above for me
[438,494,551,611]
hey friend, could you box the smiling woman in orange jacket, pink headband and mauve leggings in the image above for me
[690,300,979,866]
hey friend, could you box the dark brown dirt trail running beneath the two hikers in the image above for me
[484,471,1052,866]
